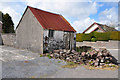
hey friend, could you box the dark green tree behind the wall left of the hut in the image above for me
[2,13,15,33]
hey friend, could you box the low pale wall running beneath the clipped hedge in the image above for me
[76,40,120,49]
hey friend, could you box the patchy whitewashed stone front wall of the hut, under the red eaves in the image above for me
[43,30,76,51]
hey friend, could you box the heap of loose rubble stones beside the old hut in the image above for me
[43,48,117,67]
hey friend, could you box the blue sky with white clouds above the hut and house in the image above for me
[0,0,118,33]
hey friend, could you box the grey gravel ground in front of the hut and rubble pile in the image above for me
[0,46,118,78]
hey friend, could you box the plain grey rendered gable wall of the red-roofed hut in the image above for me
[16,8,43,53]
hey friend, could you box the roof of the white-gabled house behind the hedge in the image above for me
[83,22,117,33]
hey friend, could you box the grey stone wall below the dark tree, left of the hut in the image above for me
[1,33,16,47]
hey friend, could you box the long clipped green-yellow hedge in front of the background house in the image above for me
[76,31,120,42]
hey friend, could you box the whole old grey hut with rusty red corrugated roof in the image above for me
[16,6,76,53]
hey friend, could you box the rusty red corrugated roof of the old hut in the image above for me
[28,6,76,32]
